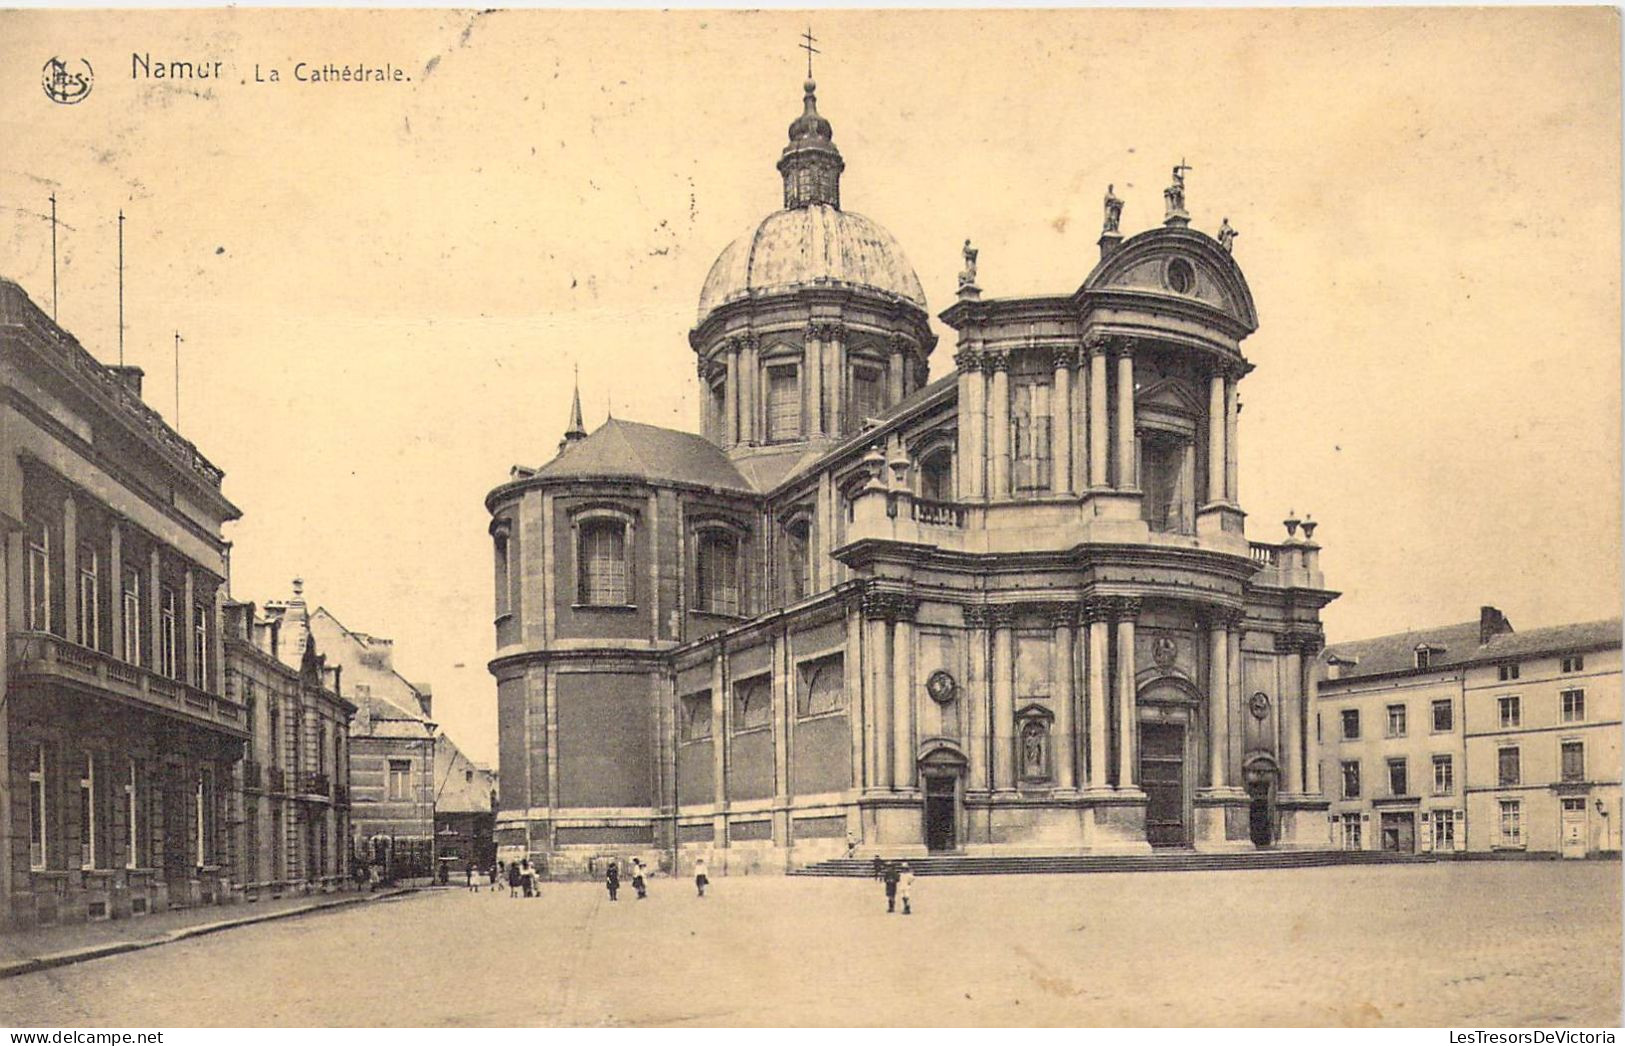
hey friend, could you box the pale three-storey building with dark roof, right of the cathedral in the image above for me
[1316,606,1622,858]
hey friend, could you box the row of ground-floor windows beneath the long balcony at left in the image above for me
[23,742,218,871]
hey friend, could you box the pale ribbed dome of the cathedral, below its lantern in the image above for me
[699,203,925,322]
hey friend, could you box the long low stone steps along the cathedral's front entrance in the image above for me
[790,849,1433,879]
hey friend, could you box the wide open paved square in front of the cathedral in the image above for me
[0,862,1620,1027]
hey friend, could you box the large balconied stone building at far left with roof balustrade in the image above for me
[0,279,249,926]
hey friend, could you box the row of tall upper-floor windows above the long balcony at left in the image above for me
[23,520,211,687]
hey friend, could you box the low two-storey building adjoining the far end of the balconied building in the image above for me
[226,603,356,900]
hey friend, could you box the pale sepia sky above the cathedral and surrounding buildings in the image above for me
[0,8,1620,762]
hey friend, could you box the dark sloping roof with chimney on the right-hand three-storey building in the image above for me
[1321,617,1620,679]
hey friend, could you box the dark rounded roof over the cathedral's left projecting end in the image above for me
[536,417,751,491]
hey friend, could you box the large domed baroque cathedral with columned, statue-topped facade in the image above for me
[486,80,1336,877]
